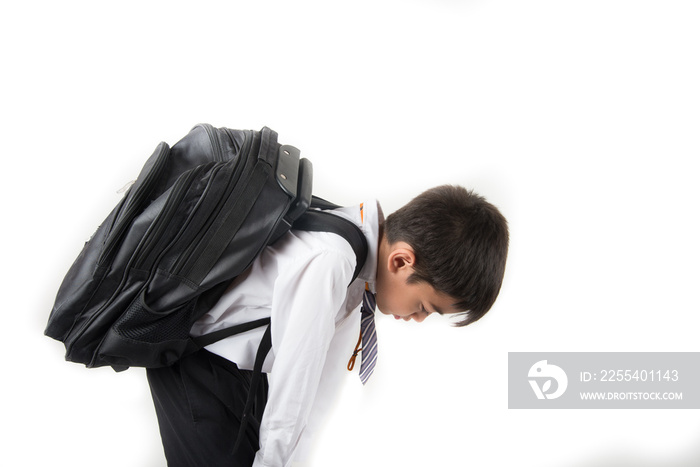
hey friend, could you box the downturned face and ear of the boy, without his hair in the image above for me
[377,242,457,323]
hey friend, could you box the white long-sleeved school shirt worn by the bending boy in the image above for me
[192,200,383,467]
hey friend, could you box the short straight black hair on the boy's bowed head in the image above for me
[384,185,508,326]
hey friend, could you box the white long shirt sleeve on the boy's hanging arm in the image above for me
[253,251,354,467]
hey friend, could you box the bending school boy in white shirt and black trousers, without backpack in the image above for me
[148,186,508,467]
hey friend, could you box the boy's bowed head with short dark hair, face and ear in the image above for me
[377,185,508,326]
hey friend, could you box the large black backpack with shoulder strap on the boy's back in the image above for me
[45,124,367,374]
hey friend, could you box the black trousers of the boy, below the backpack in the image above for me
[146,349,268,467]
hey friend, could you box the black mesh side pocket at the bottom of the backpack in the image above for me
[114,296,196,344]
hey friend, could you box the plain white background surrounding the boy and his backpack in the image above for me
[0,0,700,467]
